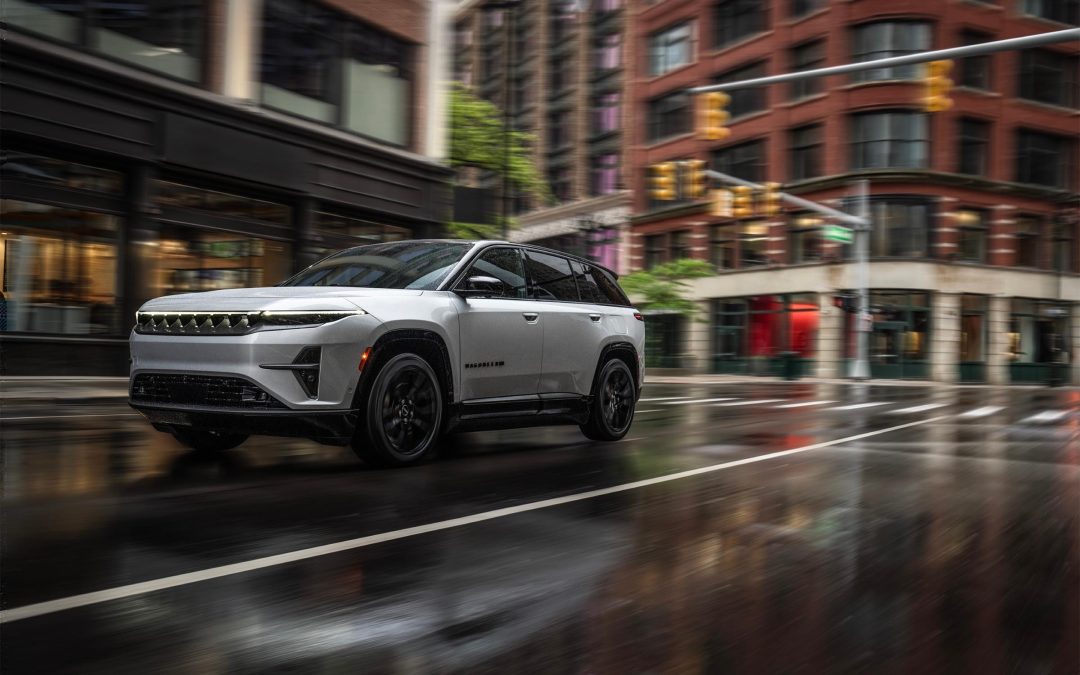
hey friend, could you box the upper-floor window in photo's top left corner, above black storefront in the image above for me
[3,0,206,82]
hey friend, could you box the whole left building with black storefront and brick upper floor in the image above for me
[0,0,450,375]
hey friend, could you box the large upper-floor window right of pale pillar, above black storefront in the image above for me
[260,0,412,145]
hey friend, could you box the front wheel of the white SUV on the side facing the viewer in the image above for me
[352,352,443,467]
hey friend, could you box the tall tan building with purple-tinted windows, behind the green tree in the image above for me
[454,0,634,271]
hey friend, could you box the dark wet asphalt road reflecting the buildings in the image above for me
[0,382,1080,674]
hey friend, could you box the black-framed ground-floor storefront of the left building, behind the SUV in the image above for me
[0,38,449,375]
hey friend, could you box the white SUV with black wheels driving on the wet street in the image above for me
[130,241,645,465]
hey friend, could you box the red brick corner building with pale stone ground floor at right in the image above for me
[630,0,1080,382]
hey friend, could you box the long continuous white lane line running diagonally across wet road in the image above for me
[0,416,945,623]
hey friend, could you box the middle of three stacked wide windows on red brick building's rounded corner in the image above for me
[851,111,930,170]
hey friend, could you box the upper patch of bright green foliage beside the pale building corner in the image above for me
[449,83,550,202]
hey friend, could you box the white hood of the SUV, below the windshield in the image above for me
[140,286,423,312]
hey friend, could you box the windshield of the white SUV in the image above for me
[282,241,472,291]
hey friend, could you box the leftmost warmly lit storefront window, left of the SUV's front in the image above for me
[0,200,120,335]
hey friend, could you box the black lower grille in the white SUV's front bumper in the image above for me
[131,373,286,410]
